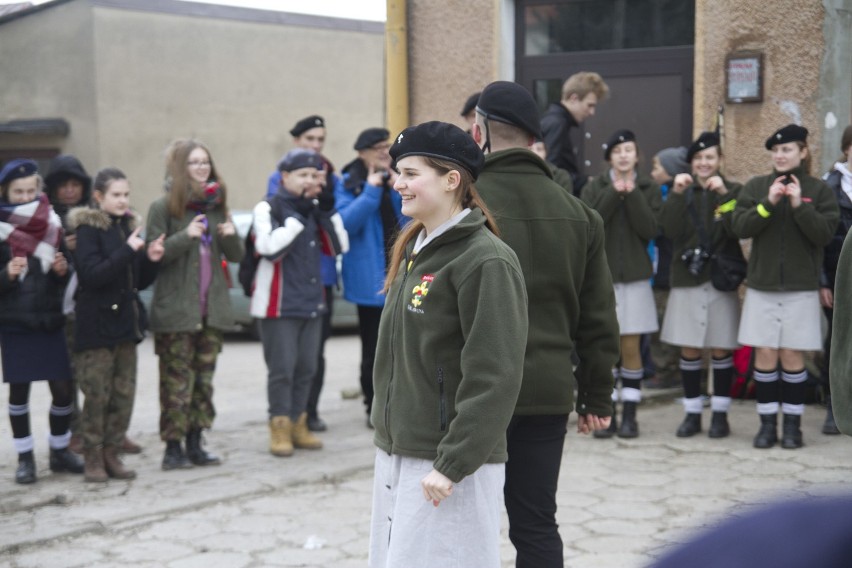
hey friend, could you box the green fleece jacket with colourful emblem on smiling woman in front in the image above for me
[371,209,527,483]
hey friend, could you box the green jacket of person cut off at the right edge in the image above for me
[829,231,852,436]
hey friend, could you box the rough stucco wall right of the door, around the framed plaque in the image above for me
[695,0,852,181]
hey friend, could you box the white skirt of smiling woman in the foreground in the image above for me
[369,450,506,568]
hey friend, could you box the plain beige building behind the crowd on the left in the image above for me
[0,0,385,211]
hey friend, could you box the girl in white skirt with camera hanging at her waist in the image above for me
[660,132,742,438]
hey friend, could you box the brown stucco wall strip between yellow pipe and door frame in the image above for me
[408,0,501,126]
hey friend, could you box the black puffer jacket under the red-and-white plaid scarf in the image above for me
[0,242,71,332]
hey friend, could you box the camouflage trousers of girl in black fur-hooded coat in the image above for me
[74,342,136,448]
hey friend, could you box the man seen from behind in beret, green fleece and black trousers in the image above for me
[471,81,618,567]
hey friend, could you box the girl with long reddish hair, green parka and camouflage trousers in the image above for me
[145,140,244,470]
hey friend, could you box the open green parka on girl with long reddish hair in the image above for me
[145,196,245,333]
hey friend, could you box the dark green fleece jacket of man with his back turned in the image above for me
[476,148,619,416]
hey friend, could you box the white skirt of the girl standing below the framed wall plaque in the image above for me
[739,288,822,351]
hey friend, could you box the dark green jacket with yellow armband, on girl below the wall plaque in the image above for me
[733,164,840,292]
